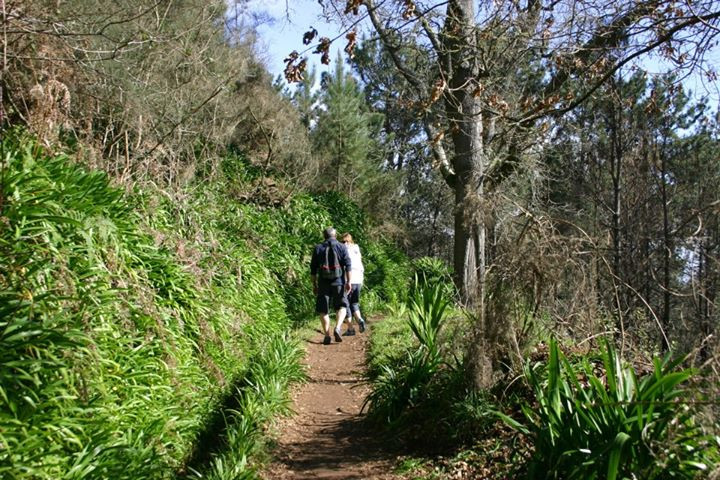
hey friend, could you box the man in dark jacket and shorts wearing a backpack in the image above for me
[310,227,351,345]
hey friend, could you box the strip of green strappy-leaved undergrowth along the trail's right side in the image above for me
[367,280,720,480]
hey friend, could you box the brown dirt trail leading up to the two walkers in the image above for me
[262,322,402,480]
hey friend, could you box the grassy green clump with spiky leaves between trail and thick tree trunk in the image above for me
[366,274,493,447]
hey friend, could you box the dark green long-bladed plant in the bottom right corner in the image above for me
[504,341,717,480]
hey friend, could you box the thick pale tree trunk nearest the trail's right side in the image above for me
[442,0,502,388]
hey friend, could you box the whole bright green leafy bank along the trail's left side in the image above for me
[0,134,406,479]
